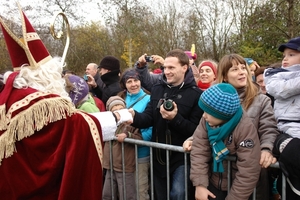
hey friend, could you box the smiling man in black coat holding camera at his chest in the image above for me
[132,49,203,200]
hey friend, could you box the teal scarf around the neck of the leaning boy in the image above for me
[206,106,243,172]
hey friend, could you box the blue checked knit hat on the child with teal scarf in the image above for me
[198,83,241,121]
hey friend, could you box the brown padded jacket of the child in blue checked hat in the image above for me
[190,113,261,200]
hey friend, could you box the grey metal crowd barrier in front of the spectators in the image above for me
[107,138,286,200]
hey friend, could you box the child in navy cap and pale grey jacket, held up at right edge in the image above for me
[264,37,300,200]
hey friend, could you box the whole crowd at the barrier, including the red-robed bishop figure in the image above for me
[0,2,300,200]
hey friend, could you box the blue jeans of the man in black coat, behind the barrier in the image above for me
[153,165,191,200]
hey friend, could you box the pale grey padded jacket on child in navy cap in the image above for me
[264,64,300,138]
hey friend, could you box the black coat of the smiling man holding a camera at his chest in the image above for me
[132,70,203,177]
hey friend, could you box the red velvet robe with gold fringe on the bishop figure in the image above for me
[0,88,103,200]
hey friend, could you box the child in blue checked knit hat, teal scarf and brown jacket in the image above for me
[190,83,261,199]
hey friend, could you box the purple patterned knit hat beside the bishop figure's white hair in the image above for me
[65,75,89,105]
